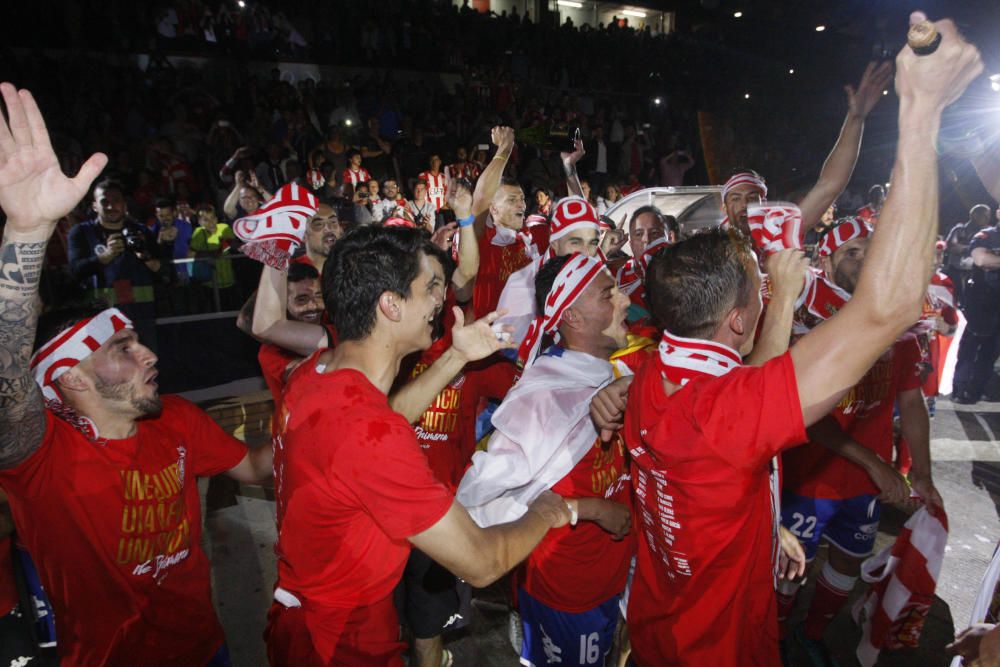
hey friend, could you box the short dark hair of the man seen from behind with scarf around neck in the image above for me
[646,228,757,338]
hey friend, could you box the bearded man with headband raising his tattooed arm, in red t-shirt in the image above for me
[0,83,271,665]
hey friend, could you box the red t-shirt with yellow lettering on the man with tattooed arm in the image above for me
[0,396,247,665]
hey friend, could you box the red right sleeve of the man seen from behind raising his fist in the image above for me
[689,352,807,468]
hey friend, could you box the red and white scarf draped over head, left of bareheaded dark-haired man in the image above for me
[233,183,319,271]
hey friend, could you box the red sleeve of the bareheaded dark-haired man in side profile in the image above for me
[329,412,453,540]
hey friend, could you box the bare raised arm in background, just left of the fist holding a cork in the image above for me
[799,61,892,233]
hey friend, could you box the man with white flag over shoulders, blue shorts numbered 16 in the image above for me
[457,252,634,665]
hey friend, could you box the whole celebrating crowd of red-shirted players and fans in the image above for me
[0,9,1000,667]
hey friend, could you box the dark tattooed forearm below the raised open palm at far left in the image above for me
[0,242,46,468]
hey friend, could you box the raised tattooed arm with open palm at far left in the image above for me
[0,83,108,468]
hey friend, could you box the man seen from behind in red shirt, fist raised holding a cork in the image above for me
[592,18,982,665]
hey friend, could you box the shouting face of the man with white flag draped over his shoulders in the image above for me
[559,271,629,358]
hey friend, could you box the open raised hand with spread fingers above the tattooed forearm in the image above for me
[0,83,108,238]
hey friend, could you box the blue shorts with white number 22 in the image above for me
[781,492,882,560]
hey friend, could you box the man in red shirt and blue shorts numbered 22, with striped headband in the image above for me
[778,218,941,662]
